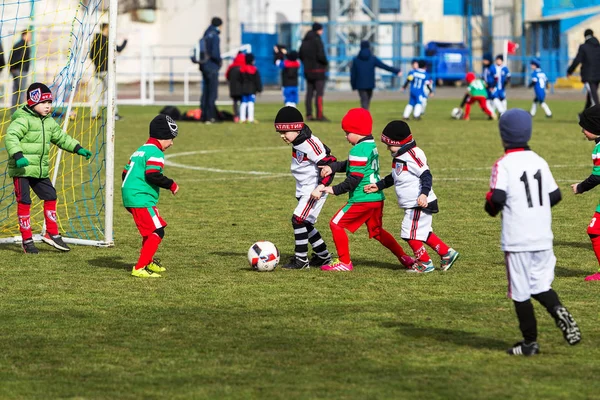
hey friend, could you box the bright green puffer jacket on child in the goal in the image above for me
[4,105,80,178]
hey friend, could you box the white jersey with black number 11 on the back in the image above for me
[490,149,558,252]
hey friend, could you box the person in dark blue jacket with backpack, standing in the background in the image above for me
[200,17,223,124]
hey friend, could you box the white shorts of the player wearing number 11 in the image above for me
[504,249,556,301]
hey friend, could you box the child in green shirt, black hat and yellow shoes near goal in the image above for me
[121,114,179,278]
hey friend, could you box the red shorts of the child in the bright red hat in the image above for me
[330,201,383,238]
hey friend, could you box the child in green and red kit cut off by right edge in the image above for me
[571,104,600,281]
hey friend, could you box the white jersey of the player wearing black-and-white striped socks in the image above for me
[290,135,328,197]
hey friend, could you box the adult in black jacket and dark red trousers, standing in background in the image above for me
[299,22,329,121]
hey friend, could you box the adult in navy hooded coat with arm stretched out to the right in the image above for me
[350,40,402,110]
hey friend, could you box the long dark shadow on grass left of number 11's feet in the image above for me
[382,322,512,350]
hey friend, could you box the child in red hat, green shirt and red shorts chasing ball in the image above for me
[321,108,415,271]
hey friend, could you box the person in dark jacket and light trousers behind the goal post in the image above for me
[90,23,127,121]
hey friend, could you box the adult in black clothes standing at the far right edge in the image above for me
[567,29,600,113]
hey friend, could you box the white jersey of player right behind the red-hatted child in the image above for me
[392,146,437,209]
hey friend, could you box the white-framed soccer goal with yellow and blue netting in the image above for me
[0,0,117,246]
